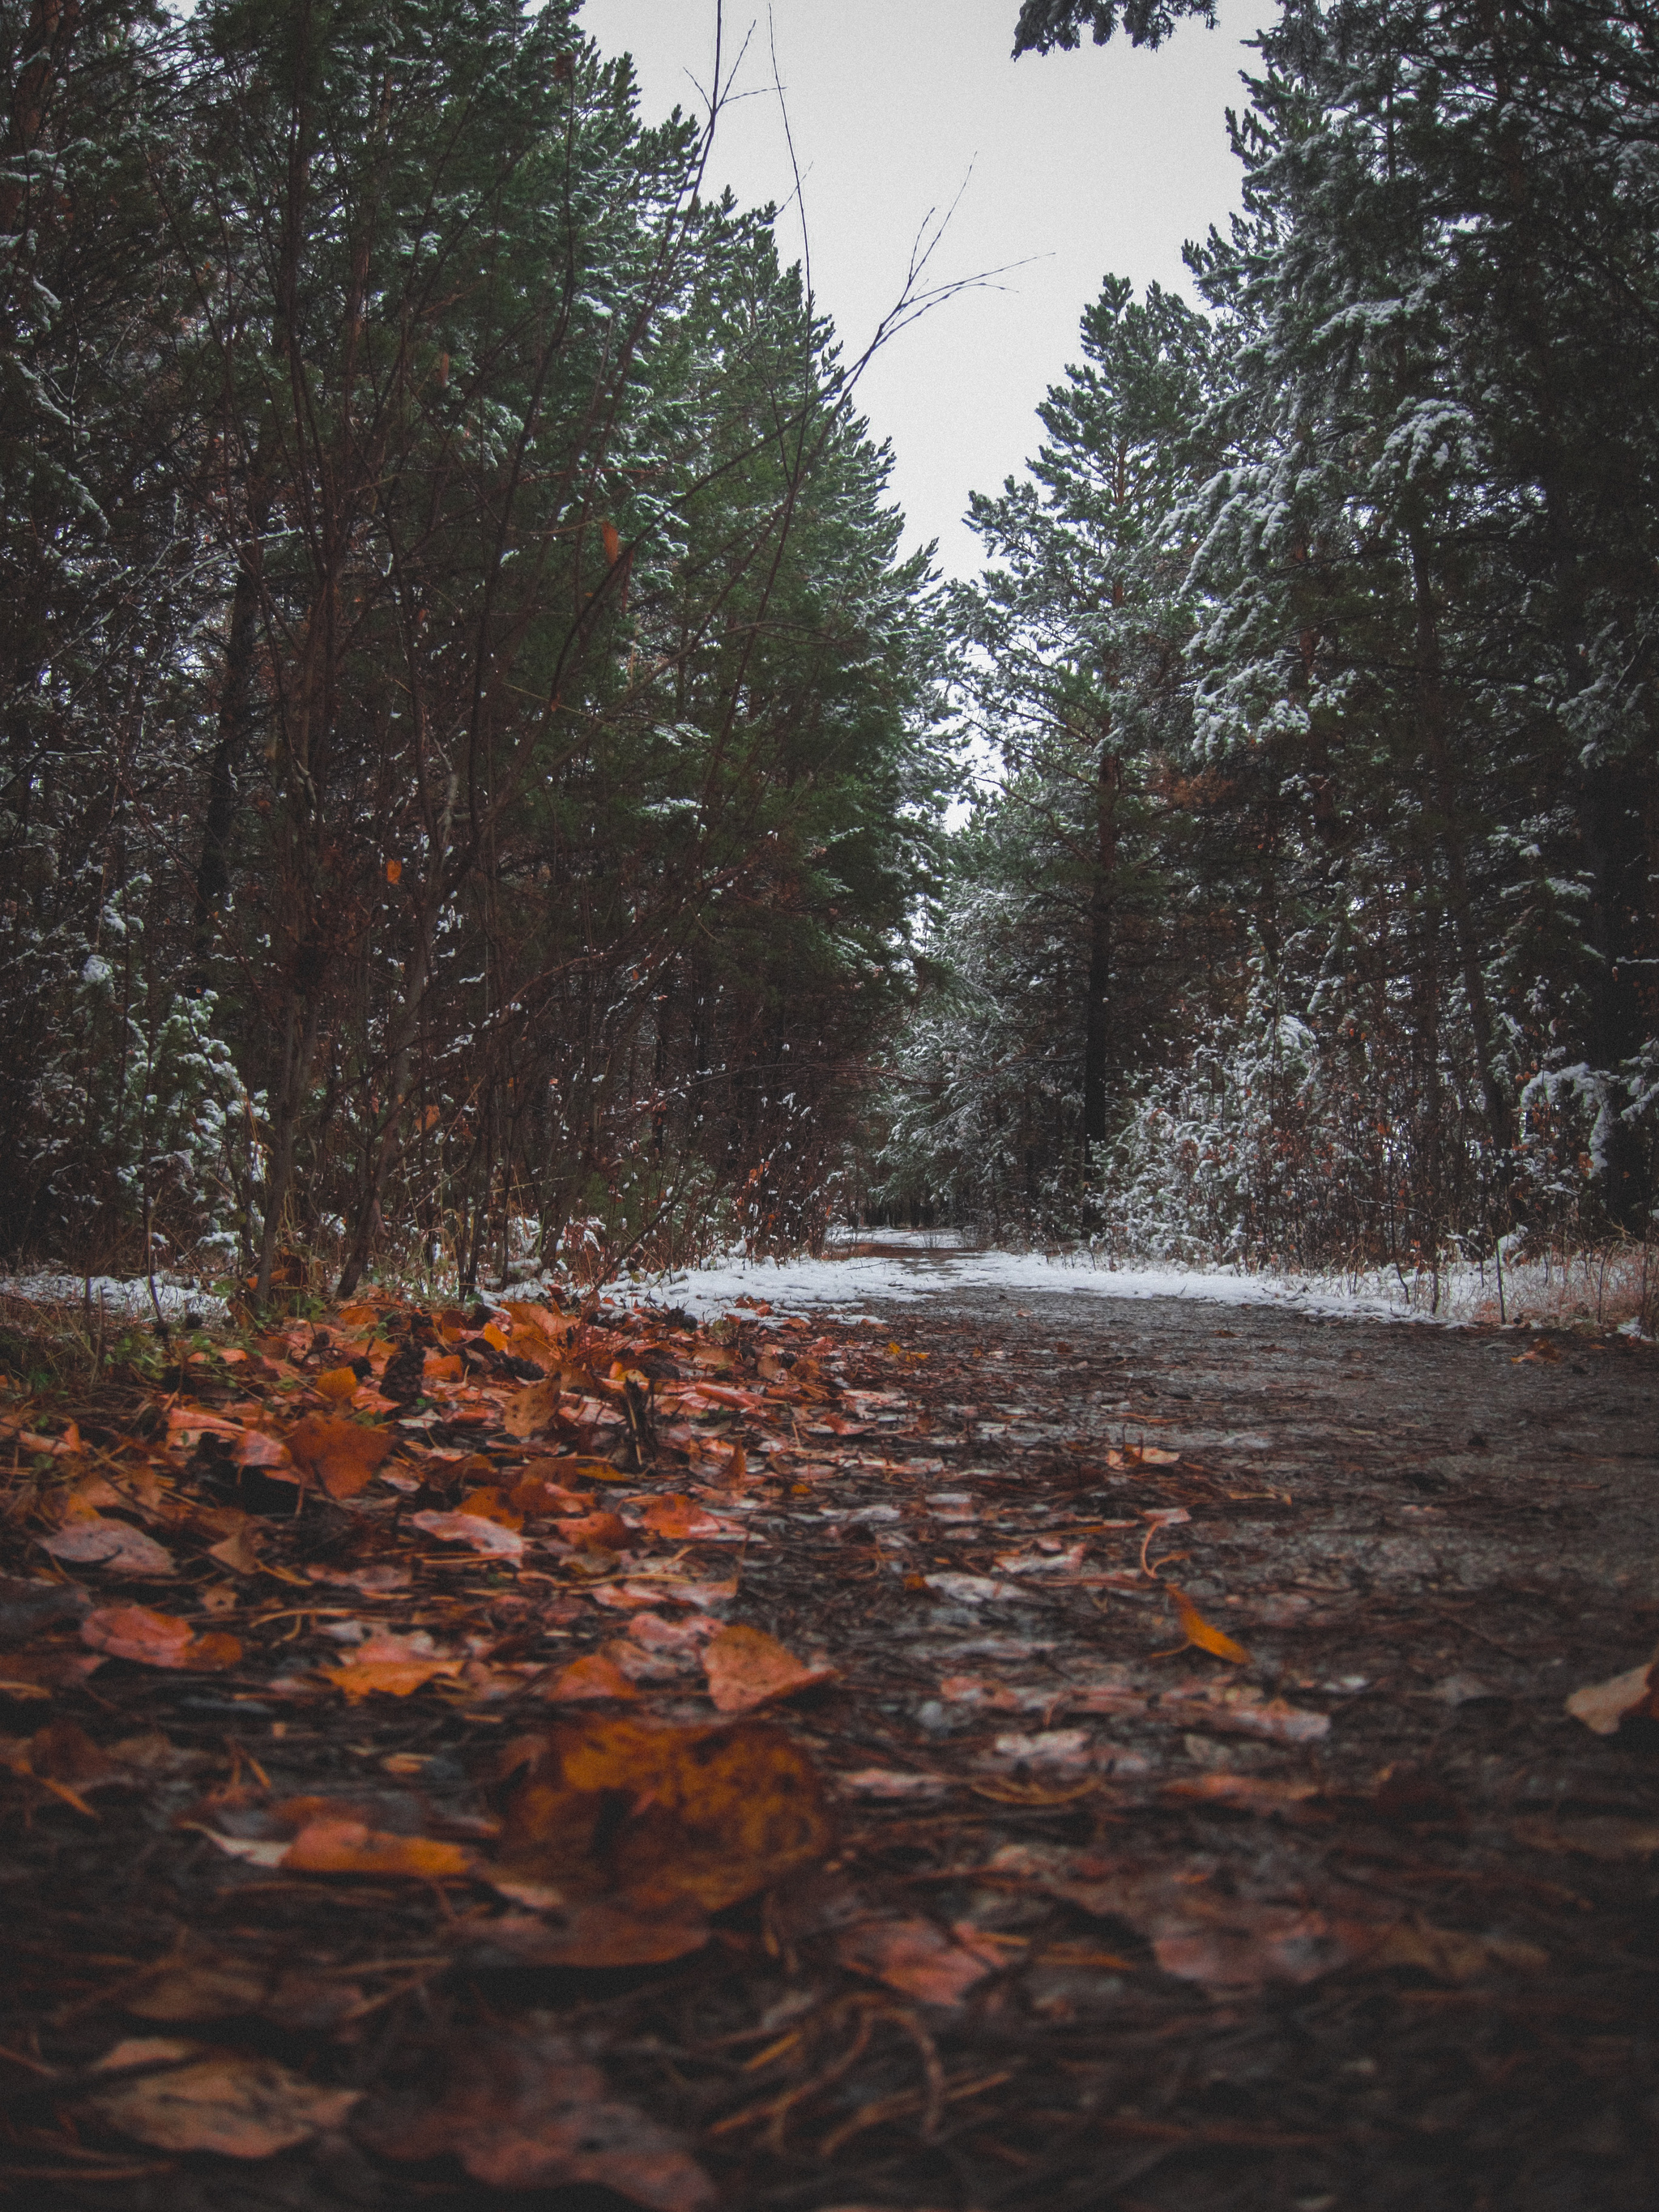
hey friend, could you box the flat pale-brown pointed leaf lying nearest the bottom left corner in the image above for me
[86,2037,363,2159]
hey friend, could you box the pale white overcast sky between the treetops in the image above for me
[582,0,1277,575]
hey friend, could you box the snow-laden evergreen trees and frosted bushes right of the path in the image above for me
[898,0,1659,1263]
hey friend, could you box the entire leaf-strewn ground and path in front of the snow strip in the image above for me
[0,1274,1659,2212]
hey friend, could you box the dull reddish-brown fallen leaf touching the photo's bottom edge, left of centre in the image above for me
[354,2028,717,2212]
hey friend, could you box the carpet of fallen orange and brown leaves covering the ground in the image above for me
[0,1298,1659,2212]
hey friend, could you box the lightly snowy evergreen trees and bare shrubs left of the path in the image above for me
[0,0,951,1298]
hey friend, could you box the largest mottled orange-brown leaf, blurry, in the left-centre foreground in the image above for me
[502,1716,832,1912]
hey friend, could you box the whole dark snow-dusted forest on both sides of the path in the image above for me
[0,0,1659,1296]
